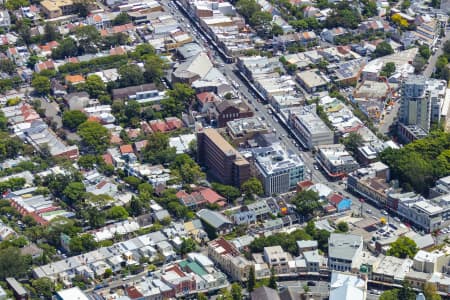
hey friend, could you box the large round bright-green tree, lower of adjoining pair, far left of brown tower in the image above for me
[77,121,109,154]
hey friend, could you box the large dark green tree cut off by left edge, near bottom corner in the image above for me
[0,247,30,280]
